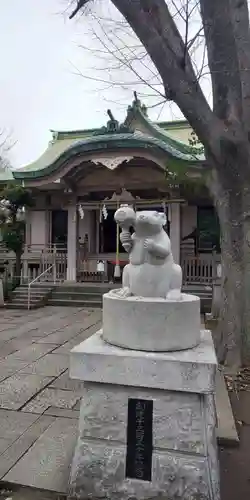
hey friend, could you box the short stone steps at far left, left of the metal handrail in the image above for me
[6,283,54,309]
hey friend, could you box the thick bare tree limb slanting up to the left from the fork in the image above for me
[105,0,219,155]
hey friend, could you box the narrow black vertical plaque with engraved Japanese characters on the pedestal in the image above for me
[126,399,153,481]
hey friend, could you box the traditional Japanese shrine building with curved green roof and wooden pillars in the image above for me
[0,94,219,284]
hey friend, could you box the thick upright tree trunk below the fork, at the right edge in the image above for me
[209,164,250,368]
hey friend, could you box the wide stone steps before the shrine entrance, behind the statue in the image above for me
[48,283,212,313]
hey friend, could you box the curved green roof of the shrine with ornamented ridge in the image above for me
[0,94,205,182]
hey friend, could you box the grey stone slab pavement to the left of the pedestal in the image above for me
[0,307,101,493]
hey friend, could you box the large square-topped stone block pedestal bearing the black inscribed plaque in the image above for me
[69,331,220,500]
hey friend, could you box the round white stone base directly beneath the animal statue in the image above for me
[103,290,201,352]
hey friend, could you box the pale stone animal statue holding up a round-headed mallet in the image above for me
[115,205,182,300]
